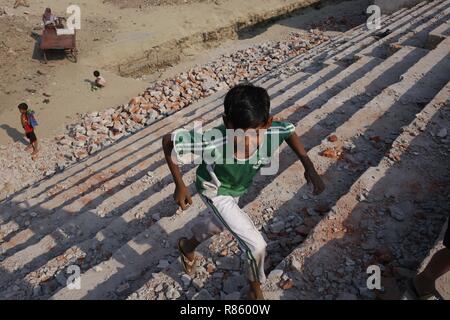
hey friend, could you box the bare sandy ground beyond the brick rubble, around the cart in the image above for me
[0,0,367,145]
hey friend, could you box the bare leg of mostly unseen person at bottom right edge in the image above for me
[414,248,450,296]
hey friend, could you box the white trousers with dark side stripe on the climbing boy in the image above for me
[192,196,267,283]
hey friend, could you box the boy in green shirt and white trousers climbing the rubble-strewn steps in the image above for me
[162,85,325,300]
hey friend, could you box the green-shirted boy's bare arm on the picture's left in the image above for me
[162,134,192,211]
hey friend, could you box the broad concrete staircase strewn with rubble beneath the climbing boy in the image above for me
[0,0,450,299]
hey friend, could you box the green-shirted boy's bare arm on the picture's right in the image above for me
[286,132,325,195]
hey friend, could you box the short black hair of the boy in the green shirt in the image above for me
[225,83,270,129]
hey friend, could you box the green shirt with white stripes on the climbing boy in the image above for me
[173,121,295,198]
